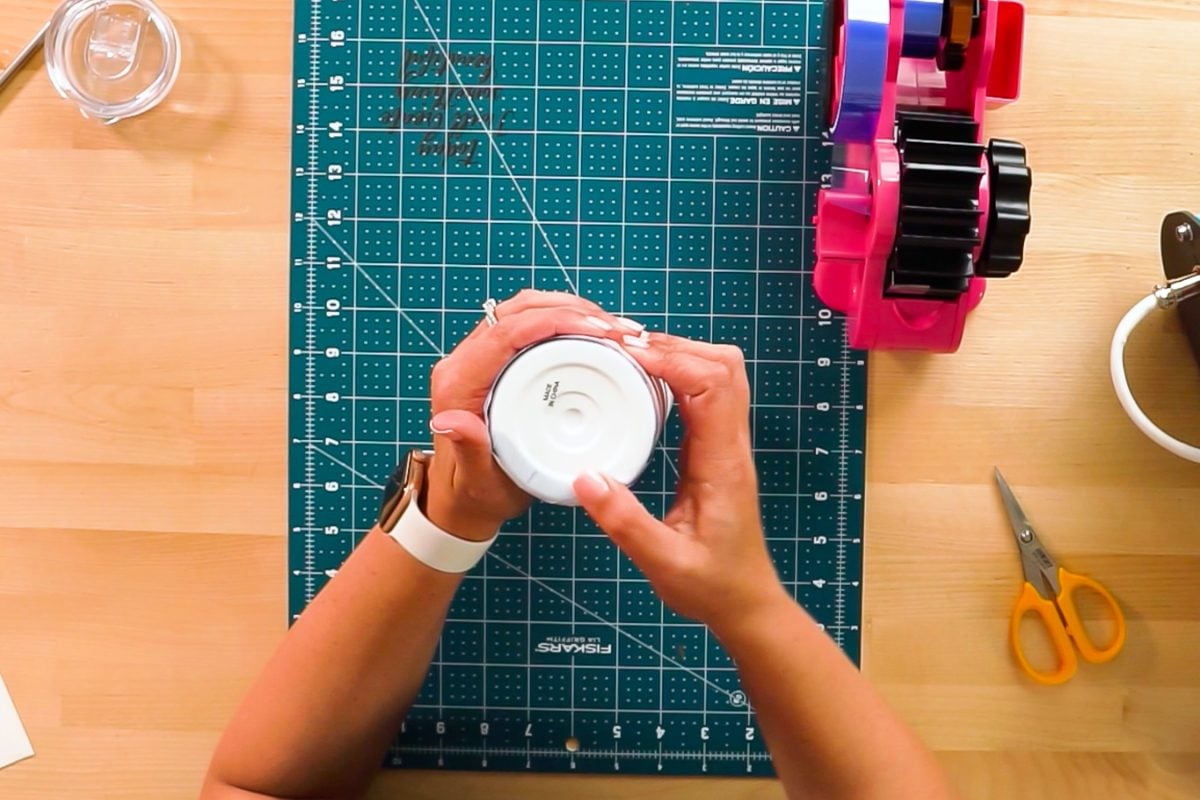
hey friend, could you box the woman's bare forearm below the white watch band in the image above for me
[202,529,461,800]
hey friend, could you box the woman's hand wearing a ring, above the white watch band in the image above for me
[425,289,641,540]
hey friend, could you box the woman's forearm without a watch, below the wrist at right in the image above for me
[716,593,956,800]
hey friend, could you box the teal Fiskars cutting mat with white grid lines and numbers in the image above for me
[289,0,865,775]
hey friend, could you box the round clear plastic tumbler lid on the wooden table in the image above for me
[46,0,180,124]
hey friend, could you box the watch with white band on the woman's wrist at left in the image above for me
[376,450,496,573]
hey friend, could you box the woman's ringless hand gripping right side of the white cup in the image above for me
[575,333,790,636]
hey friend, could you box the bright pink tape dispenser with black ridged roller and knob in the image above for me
[814,0,1032,353]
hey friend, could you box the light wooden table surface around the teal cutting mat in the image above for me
[0,0,1200,800]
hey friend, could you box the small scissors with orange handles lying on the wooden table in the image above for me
[996,469,1126,685]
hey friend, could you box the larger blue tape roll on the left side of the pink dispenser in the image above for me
[829,0,890,144]
